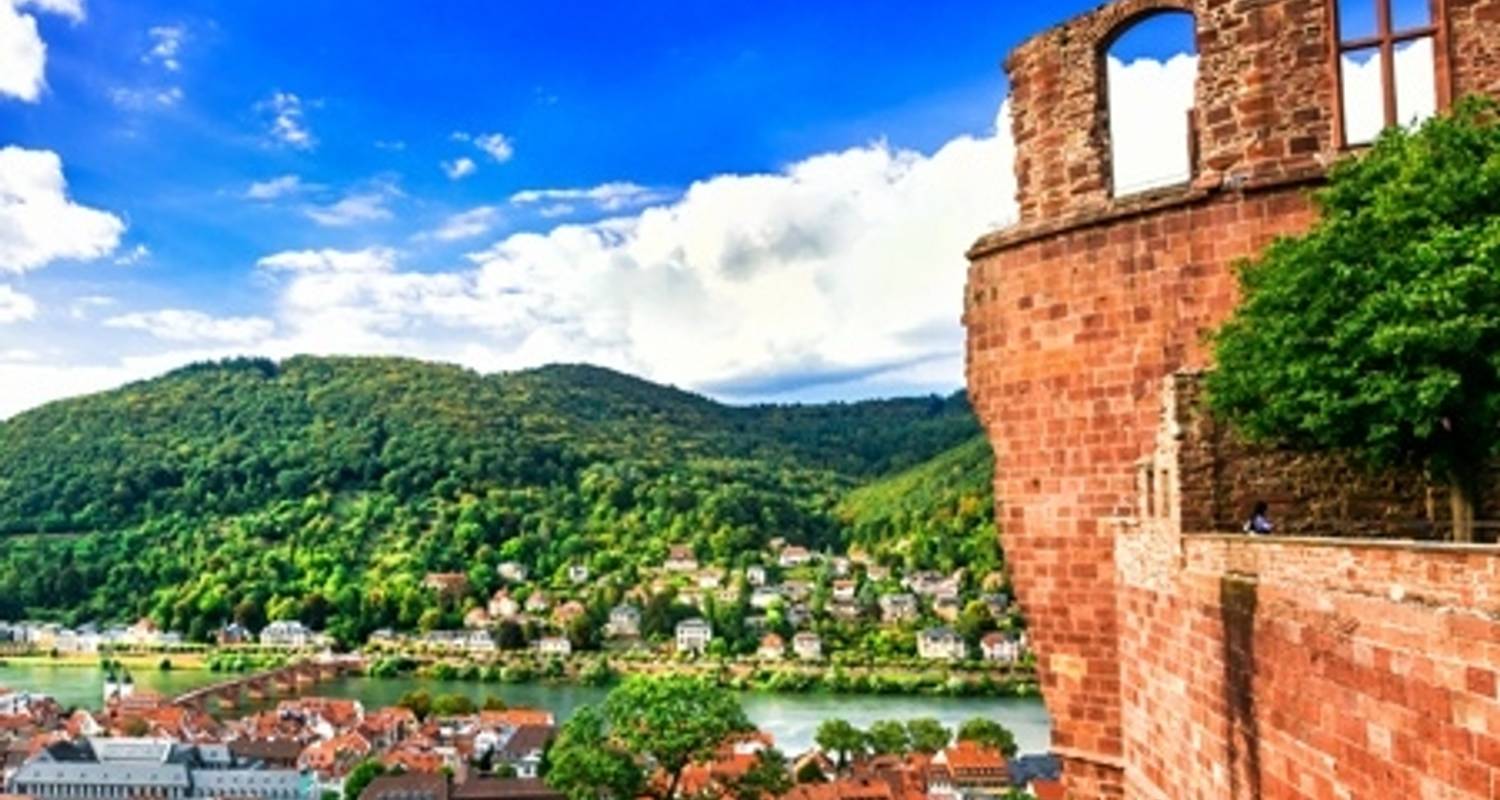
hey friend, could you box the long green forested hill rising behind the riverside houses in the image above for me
[0,357,998,642]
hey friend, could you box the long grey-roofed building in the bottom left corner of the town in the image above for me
[6,738,317,800]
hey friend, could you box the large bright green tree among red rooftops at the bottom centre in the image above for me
[549,675,755,800]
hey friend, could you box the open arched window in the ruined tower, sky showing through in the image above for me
[1106,12,1199,197]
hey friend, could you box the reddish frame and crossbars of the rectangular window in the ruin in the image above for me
[1325,0,1452,150]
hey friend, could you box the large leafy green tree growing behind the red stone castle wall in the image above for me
[1208,99,1500,540]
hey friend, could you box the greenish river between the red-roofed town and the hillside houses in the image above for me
[0,662,1052,753]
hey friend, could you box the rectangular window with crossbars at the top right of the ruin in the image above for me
[1334,0,1442,146]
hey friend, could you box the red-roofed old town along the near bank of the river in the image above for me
[0,666,1061,800]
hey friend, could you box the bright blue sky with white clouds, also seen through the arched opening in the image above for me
[0,0,1196,417]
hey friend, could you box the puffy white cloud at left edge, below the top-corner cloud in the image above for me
[0,147,125,273]
